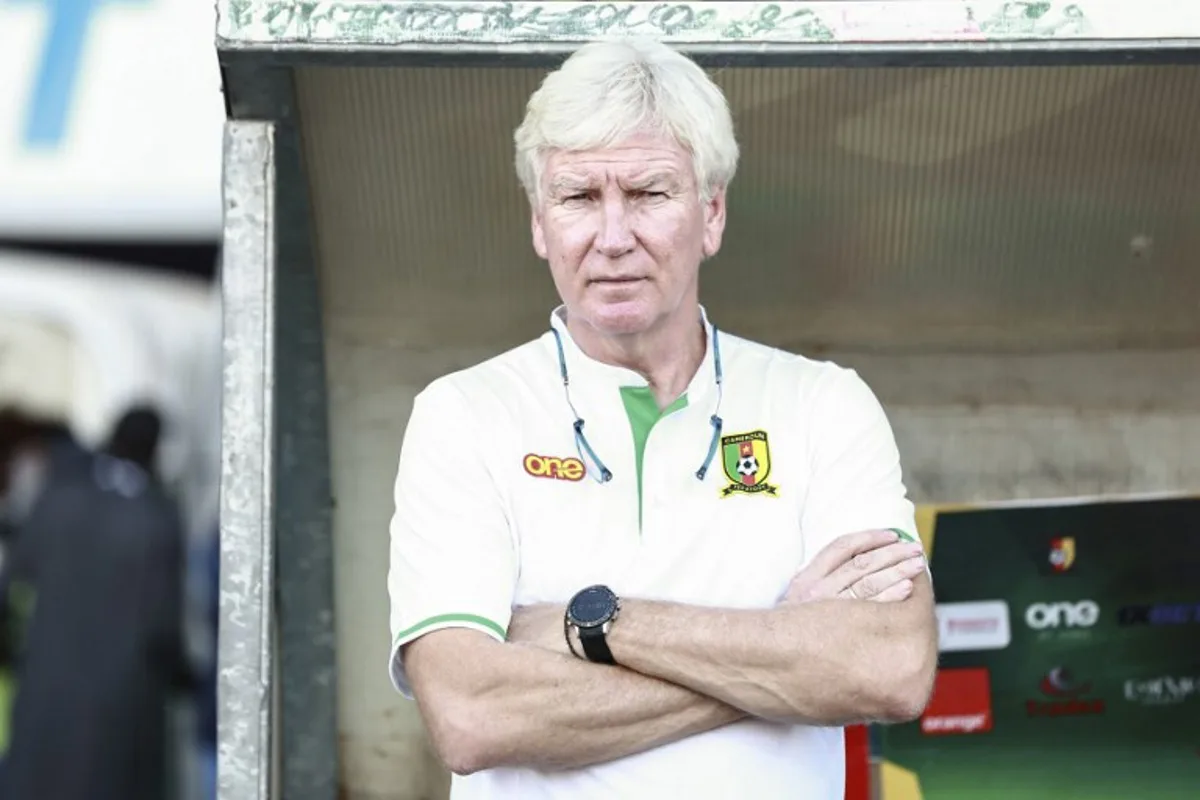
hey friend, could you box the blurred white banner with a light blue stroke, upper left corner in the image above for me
[0,0,224,241]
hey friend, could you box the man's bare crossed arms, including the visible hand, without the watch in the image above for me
[404,531,936,775]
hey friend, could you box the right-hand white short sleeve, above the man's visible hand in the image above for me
[800,368,917,560]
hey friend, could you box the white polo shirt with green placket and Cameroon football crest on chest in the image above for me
[388,304,916,800]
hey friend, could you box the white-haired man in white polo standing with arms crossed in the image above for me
[389,42,936,800]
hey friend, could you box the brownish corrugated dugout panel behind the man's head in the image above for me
[298,66,1200,351]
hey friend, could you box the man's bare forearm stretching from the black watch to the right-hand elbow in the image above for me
[608,577,937,724]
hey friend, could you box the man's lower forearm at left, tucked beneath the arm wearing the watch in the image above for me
[406,631,745,774]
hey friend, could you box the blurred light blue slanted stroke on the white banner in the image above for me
[7,0,146,149]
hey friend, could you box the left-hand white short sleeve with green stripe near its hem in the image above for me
[388,379,516,698]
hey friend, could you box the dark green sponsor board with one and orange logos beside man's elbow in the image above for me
[878,498,1200,800]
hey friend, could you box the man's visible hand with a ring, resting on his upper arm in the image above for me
[781,530,925,603]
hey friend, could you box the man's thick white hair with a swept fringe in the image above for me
[512,40,738,204]
